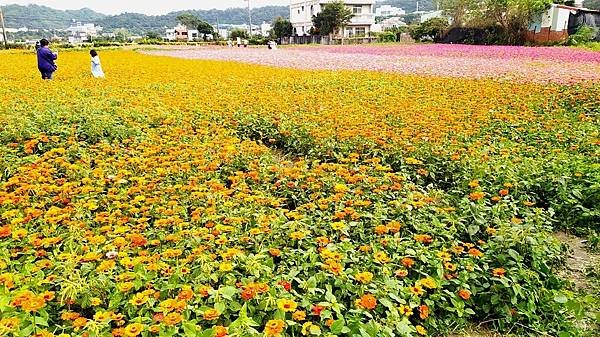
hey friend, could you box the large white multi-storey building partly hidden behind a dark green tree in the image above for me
[290,0,375,37]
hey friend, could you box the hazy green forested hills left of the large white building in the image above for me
[3,5,289,32]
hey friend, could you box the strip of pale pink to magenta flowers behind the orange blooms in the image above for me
[147,44,600,84]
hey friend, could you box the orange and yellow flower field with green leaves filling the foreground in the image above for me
[0,49,600,337]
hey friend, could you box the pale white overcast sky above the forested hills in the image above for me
[0,0,290,15]
